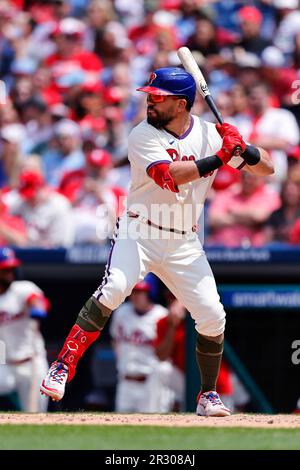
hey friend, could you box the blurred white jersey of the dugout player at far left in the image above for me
[0,281,45,362]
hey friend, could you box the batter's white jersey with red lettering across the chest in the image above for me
[128,115,244,230]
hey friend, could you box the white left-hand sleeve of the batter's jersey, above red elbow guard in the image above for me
[128,123,173,172]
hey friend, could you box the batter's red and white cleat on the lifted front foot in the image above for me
[40,361,68,401]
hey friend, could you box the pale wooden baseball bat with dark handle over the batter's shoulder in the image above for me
[177,47,242,156]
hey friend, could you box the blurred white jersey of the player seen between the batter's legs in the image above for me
[110,302,168,376]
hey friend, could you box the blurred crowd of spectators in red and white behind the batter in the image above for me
[0,0,300,247]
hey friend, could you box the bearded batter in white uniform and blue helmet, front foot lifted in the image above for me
[41,67,274,416]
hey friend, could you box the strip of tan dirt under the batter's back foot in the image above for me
[0,413,300,429]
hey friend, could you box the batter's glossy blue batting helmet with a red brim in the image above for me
[137,67,196,106]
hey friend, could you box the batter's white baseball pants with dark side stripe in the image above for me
[93,215,225,336]
